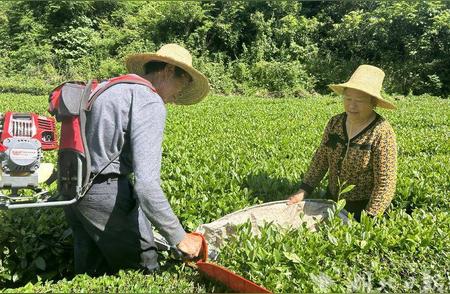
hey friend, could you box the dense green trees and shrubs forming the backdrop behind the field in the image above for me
[0,0,450,97]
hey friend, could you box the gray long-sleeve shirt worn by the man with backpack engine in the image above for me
[86,80,186,245]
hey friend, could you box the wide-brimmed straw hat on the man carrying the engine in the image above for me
[125,44,209,105]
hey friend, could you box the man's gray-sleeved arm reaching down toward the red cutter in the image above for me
[129,86,186,245]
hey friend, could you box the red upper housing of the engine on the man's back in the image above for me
[0,112,58,152]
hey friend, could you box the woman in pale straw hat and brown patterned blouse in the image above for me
[288,65,397,219]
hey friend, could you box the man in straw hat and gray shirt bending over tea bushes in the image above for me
[66,44,209,275]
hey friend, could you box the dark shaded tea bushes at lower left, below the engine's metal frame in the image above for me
[0,209,73,286]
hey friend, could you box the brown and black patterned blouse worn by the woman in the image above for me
[300,112,397,215]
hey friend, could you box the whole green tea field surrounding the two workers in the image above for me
[0,93,450,292]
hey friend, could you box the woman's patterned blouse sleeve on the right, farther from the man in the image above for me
[365,124,397,215]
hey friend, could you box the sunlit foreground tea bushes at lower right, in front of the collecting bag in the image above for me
[220,210,450,293]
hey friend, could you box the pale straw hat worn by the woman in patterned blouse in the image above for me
[328,64,397,109]
